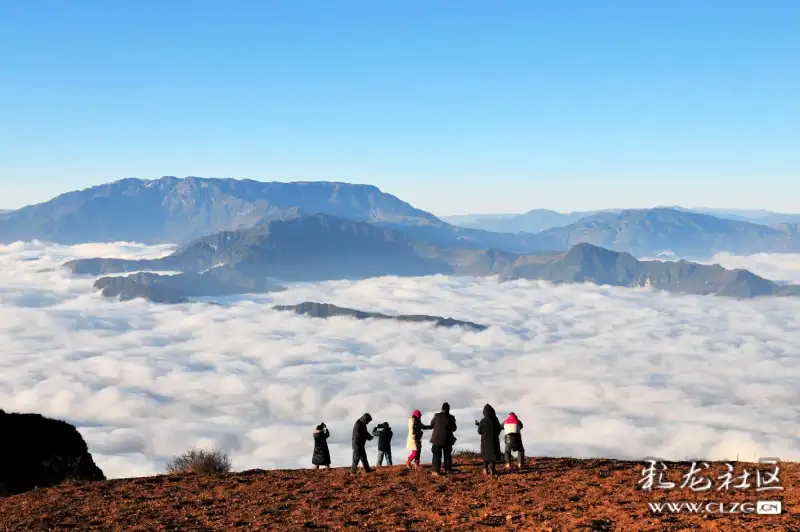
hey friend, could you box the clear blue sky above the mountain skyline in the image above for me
[0,0,800,215]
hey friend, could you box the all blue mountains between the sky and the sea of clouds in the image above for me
[0,177,800,303]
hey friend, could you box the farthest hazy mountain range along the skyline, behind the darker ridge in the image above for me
[0,177,800,260]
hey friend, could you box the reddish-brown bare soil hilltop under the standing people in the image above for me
[0,456,800,532]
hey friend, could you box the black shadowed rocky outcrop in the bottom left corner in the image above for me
[0,410,105,495]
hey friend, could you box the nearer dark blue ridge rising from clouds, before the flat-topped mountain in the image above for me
[65,214,800,302]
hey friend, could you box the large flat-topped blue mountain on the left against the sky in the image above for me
[0,176,436,244]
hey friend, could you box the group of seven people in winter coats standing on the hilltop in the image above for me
[311,403,525,475]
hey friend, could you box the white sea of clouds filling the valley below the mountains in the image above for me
[0,242,800,477]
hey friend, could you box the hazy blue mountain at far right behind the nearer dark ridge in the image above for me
[537,208,800,259]
